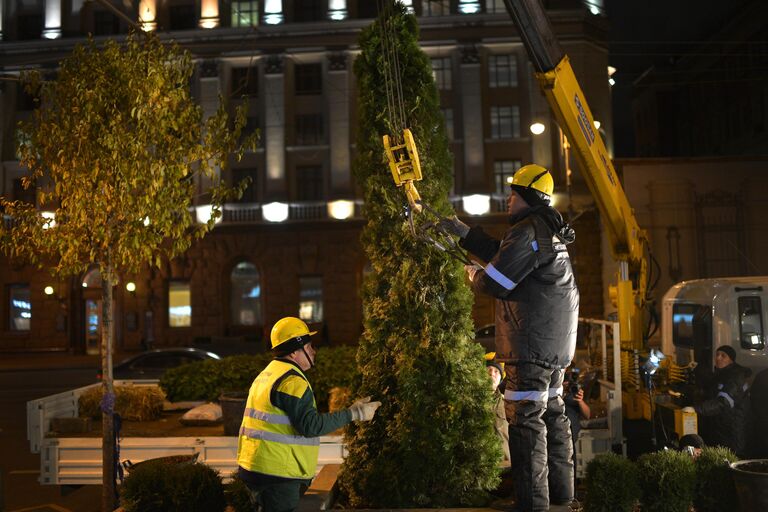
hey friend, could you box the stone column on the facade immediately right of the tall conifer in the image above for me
[459,46,485,192]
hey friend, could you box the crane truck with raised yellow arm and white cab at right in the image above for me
[504,0,768,436]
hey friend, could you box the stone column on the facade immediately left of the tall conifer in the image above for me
[327,52,351,197]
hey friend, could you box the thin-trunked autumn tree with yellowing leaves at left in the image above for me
[0,34,253,512]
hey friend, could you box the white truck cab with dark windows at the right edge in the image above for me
[661,276,768,375]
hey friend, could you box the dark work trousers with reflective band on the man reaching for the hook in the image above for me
[504,363,573,512]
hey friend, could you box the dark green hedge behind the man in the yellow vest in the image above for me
[160,347,359,410]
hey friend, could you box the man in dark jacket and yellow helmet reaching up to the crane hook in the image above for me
[442,165,579,512]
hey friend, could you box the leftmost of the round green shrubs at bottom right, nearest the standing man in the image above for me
[585,453,640,512]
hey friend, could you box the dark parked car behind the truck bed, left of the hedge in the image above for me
[98,347,221,380]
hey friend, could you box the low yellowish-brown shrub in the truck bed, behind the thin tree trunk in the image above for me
[77,385,165,421]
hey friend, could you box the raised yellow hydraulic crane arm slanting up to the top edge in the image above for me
[504,0,648,350]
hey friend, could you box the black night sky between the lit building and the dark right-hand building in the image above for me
[606,0,752,157]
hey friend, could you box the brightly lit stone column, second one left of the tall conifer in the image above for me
[264,55,285,195]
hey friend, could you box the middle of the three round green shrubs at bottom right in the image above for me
[637,450,696,512]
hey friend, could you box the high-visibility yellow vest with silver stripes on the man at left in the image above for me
[237,360,320,479]
